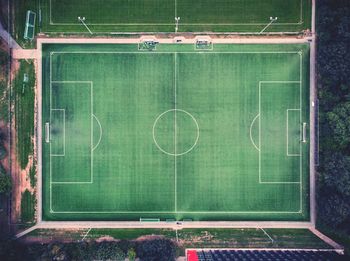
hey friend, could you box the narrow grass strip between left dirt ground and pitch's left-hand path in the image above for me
[13,60,35,169]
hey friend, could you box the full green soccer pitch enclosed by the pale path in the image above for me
[42,44,309,220]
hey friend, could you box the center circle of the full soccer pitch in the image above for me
[152,109,199,156]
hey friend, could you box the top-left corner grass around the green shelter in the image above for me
[11,0,39,48]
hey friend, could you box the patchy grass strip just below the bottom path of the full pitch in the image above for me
[23,228,329,255]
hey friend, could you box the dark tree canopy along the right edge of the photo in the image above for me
[317,0,350,241]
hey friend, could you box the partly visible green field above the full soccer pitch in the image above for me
[39,0,312,33]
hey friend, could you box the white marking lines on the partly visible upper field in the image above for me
[49,0,303,26]
